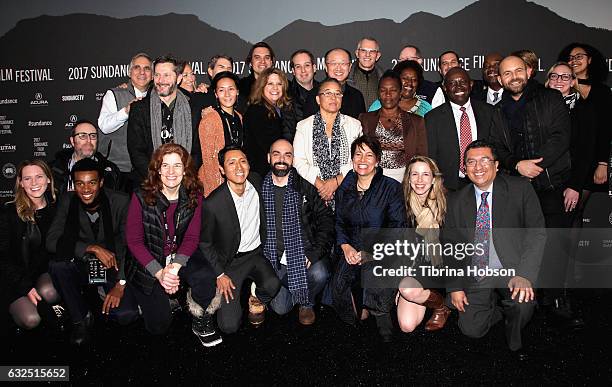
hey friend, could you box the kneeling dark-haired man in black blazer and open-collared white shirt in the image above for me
[200,146,281,333]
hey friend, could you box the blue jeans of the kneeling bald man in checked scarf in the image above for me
[270,260,329,315]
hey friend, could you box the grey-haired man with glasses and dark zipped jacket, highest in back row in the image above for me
[348,37,383,108]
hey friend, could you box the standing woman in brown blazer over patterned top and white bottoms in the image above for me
[359,70,427,183]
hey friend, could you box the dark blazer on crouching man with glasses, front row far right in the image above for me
[442,174,546,291]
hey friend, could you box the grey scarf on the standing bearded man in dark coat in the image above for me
[149,88,192,152]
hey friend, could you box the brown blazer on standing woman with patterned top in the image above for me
[359,109,427,162]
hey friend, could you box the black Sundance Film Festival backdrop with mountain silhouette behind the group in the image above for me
[0,0,612,206]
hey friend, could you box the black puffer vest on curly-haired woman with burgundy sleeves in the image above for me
[128,187,196,294]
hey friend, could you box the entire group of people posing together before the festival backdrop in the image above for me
[0,37,612,350]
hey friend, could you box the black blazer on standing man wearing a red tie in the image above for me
[425,99,501,190]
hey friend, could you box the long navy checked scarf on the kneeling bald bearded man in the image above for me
[261,170,309,305]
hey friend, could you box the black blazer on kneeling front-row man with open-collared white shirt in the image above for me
[200,173,266,276]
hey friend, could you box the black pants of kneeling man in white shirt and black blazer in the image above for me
[217,248,281,333]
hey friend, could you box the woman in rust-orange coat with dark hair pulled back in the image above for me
[198,71,244,197]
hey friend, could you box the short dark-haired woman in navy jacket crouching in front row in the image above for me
[330,136,406,342]
